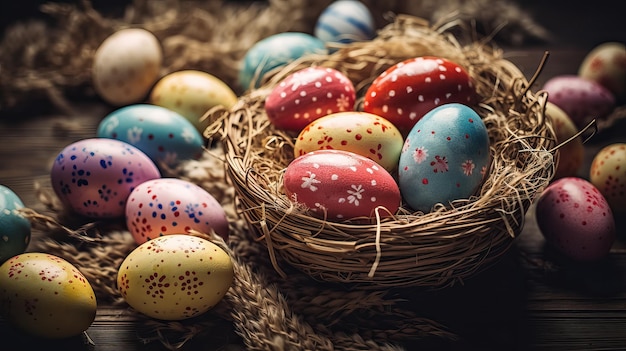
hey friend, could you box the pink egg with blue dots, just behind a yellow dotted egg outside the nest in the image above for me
[126,178,228,244]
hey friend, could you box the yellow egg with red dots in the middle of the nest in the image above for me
[294,111,404,172]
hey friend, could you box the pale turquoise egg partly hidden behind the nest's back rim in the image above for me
[238,32,327,90]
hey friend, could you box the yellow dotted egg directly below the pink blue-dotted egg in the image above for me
[117,234,234,320]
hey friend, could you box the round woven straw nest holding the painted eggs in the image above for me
[205,15,556,287]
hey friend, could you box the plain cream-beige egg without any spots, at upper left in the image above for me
[92,28,163,106]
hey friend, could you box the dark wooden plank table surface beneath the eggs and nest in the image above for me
[0,3,626,351]
